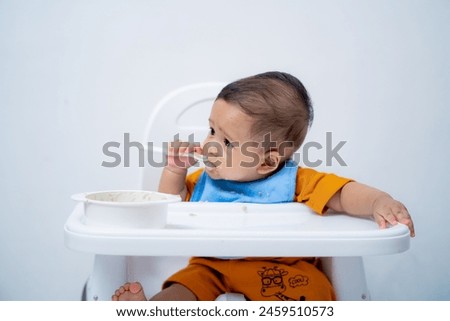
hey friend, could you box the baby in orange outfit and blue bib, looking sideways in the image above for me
[112,72,414,301]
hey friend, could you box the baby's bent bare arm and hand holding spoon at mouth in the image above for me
[158,142,201,200]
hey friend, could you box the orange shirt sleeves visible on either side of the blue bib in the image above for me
[185,167,351,214]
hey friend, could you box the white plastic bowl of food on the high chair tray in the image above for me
[72,190,181,229]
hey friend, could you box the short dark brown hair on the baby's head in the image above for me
[216,71,314,157]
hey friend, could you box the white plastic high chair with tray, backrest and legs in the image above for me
[64,83,410,300]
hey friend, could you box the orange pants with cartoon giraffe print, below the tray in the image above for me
[163,257,336,301]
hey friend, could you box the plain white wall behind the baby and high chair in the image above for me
[0,0,450,300]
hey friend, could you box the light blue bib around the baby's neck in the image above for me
[190,160,298,204]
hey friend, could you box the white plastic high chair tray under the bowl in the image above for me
[64,202,410,257]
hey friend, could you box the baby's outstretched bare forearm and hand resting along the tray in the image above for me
[327,182,415,236]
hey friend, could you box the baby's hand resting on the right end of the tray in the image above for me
[373,196,415,237]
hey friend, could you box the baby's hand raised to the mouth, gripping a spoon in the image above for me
[167,141,202,171]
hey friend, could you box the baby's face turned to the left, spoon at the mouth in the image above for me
[202,99,265,181]
